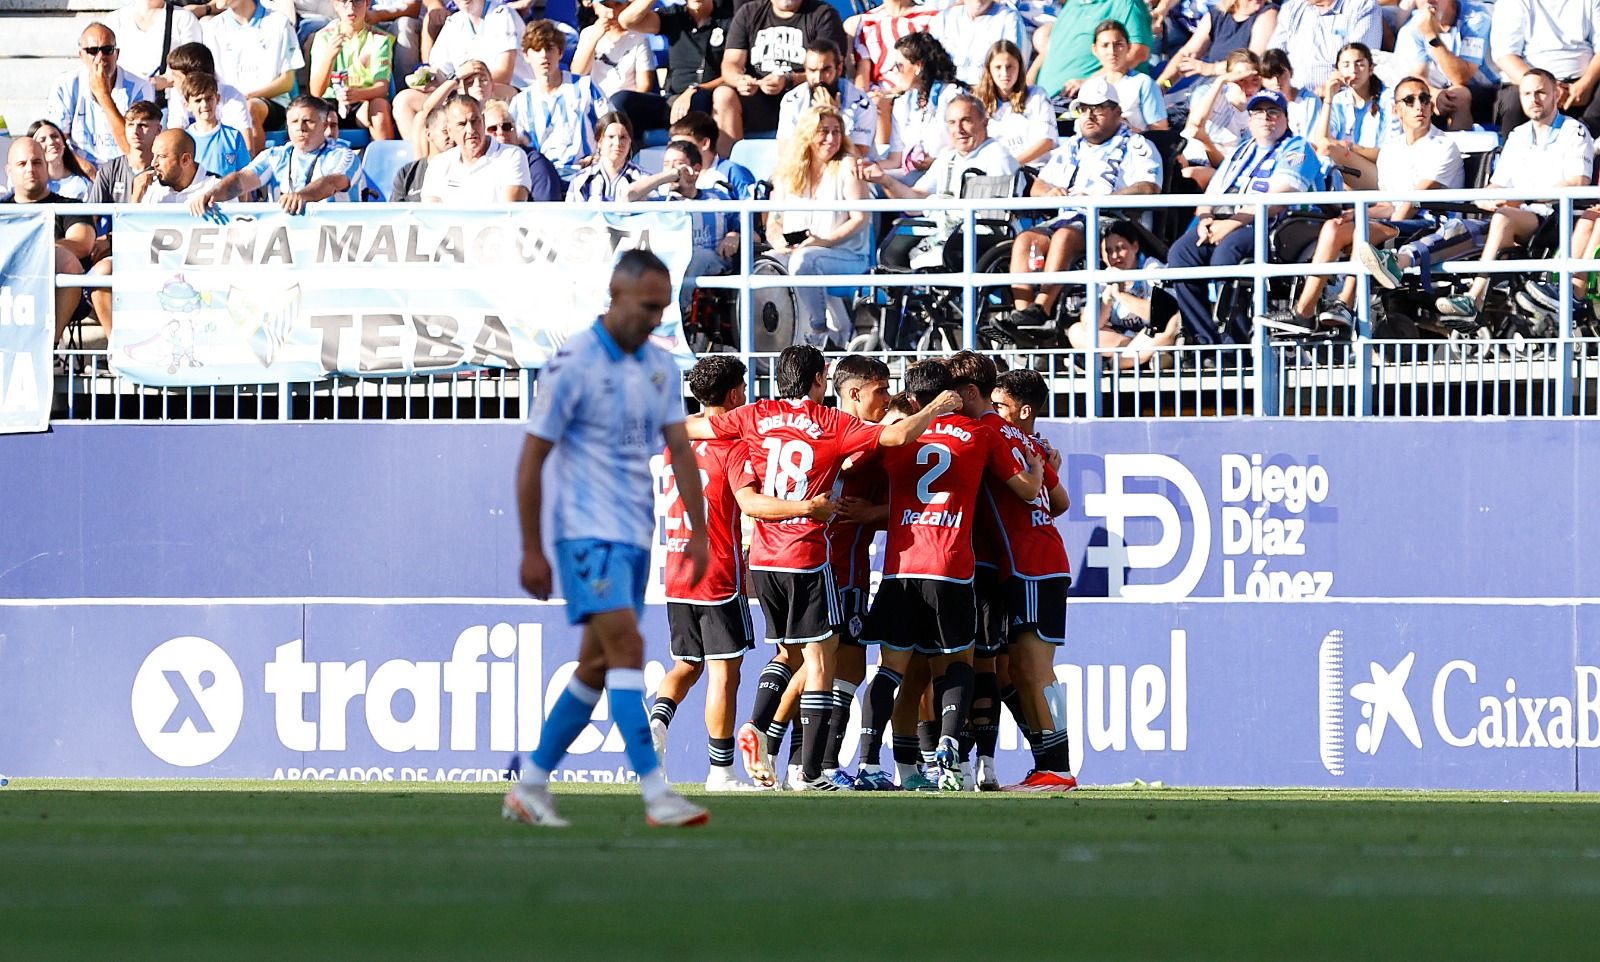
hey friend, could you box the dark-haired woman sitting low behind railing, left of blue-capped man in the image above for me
[1067,221,1182,370]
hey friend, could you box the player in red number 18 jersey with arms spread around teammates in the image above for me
[686,344,960,791]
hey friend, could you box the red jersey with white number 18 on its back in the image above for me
[710,399,883,571]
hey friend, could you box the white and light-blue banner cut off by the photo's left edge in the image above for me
[0,208,56,434]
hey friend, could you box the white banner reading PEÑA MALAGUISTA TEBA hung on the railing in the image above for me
[110,203,693,386]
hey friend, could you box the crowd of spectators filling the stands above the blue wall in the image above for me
[6,0,1600,348]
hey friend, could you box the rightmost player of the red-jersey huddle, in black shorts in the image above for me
[990,363,1078,792]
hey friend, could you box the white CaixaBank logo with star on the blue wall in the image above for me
[1317,629,1600,776]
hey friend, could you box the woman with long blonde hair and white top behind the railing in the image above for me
[766,106,872,347]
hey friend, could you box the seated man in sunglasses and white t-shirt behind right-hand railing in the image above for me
[1269,77,1462,328]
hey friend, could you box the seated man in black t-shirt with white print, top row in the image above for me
[712,0,850,146]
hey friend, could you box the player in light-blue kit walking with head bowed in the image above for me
[501,251,710,828]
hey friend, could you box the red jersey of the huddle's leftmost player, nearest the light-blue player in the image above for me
[656,440,754,605]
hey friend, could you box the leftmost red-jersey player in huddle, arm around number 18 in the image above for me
[650,354,834,792]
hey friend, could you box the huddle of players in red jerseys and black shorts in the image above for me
[651,346,1077,792]
